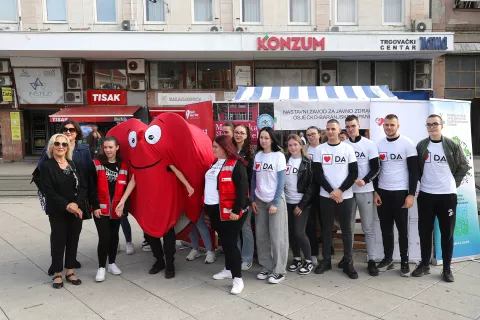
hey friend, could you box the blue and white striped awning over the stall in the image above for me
[233,86,397,102]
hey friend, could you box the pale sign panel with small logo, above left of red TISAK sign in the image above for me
[13,68,64,104]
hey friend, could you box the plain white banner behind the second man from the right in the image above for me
[370,100,429,262]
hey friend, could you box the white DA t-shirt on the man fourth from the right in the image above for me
[313,142,357,199]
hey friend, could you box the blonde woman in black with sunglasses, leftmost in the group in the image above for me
[41,134,87,289]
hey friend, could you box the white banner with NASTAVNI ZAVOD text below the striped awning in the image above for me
[274,100,370,130]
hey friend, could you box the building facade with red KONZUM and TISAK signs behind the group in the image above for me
[0,0,454,160]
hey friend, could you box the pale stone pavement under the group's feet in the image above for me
[0,197,480,320]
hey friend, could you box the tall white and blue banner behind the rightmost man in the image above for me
[430,99,480,264]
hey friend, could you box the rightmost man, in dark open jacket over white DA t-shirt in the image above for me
[412,114,470,282]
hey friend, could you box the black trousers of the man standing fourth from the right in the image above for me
[320,197,354,263]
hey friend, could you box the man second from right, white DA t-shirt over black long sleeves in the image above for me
[374,114,418,277]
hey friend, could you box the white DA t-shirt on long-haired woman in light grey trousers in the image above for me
[253,151,287,202]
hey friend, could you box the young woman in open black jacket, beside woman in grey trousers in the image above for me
[285,134,318,275]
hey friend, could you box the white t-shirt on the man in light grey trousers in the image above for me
[346,137,378,193]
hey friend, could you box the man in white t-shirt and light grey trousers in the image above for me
[344,115,380,276]
